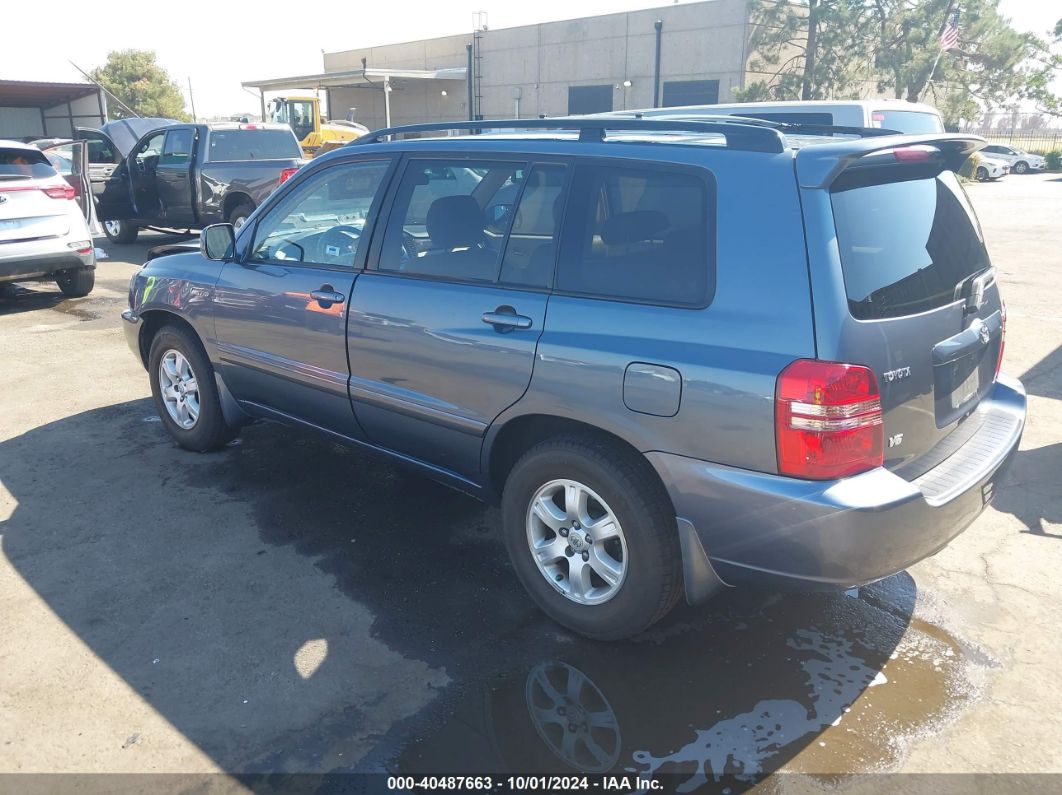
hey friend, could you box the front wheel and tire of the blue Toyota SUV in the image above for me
[148,326,239,452]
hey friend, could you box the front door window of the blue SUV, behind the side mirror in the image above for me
[251,160,391,267]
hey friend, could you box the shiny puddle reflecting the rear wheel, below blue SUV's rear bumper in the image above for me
[379,574,980,792]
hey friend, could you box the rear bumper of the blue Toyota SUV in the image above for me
[648,376,1026,593]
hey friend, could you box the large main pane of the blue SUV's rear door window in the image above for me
[379,160,527,281]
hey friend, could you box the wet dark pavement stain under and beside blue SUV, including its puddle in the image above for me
[180,416,994,791]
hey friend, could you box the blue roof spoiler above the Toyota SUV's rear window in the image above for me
[797,133,988,188]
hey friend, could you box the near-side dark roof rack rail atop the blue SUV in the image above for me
[346,117,786,154]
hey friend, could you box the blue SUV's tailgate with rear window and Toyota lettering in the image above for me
[830,161,1004,477]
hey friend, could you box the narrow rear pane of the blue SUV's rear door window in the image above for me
[494,166,568,288]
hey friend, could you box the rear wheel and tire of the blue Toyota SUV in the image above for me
[502,436,682,640]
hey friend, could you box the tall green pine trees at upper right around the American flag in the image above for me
[737,0,1062,123]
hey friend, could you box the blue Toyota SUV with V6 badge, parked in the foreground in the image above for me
[122,118,1025,639]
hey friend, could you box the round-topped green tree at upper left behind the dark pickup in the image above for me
[90,50,189,121]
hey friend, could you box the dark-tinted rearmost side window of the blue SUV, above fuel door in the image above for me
[556,165,715,307]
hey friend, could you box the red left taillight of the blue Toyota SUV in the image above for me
[774,359,885,480]
